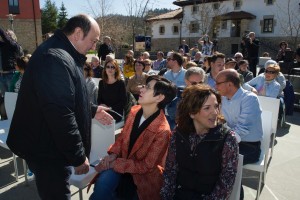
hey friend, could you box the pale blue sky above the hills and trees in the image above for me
[40,0,179,17]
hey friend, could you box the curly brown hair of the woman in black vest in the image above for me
[176,84,221,134]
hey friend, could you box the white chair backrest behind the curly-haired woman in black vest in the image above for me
[229,154,244,200]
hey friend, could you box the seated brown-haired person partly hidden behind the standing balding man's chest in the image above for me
[83,63,98,105]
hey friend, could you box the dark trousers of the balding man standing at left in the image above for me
[27,161,72,200]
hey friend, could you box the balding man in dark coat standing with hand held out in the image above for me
[7,15,112,200]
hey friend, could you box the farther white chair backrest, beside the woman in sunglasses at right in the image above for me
[258,96,280,133]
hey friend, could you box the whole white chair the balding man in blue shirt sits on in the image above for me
[243,110,272,200]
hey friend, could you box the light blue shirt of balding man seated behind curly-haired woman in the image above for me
[221,88,263,142]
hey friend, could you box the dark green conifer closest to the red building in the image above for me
[42,0,58,34]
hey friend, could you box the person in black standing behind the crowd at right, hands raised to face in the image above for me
[246,32,260,77]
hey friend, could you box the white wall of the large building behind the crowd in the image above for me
[152,0,300,57]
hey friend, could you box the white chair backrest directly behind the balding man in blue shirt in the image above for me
[260,110,273,161]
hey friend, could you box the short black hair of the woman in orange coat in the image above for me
[146,75,176,109]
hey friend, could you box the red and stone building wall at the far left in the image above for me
[0,0,42,53]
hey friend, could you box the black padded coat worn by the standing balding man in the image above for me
[7,31,97,166]
